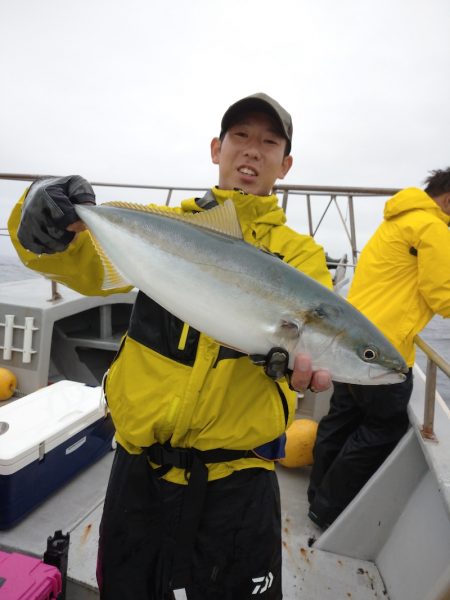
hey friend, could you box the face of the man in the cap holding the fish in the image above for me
[211,112,292,196]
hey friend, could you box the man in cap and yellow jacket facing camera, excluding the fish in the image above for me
[9,93,331,600]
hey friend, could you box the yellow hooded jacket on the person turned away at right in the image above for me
[348,188,450,367]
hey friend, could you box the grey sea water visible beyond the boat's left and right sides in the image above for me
[0,256,450,407]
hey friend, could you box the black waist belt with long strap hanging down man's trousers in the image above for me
[143,442,250,590]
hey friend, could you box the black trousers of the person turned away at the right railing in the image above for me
[308,369,413,527]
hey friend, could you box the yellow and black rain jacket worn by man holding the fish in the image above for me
[9,188,332,483]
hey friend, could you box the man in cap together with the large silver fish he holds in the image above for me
[9,93,405,600]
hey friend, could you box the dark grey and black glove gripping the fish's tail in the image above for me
[17,175,95,254]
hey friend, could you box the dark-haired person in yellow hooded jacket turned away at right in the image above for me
[308,168,450,528]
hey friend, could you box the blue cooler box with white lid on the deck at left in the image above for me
[0,381,114,529]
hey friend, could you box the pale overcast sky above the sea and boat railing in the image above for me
[0,0,450,254]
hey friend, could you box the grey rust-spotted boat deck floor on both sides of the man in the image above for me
[0,452,388,600]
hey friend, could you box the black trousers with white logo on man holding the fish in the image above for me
[97,446,282,600]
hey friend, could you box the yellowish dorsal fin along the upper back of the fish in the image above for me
[102,199,243,240]
